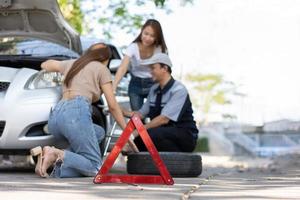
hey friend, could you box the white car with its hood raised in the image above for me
[0,0,127,155]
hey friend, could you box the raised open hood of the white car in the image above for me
[0,0,82,54]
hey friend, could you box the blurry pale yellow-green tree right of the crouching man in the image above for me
[186,74,237,123]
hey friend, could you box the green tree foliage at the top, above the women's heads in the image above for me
[58,0,193,39]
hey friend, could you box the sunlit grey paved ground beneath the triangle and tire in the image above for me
[0,155,300,200]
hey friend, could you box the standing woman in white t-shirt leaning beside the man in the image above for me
[113,19,167,110]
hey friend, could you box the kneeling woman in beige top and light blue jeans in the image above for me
[31,43,131,178]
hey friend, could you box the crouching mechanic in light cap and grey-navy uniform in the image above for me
[123,53,198,152]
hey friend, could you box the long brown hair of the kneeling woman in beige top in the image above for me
[64,43,112,87]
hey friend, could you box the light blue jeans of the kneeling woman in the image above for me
[48,96,105,178]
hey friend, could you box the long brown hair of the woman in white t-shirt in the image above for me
[133,19,168,53]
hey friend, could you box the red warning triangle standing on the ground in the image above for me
[94,115,174,185]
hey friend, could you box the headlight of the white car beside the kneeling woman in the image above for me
[26,70,63,90]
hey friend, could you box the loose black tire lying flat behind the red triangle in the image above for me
[127,152,202,177]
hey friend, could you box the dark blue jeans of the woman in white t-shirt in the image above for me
[128,75,153,111]
